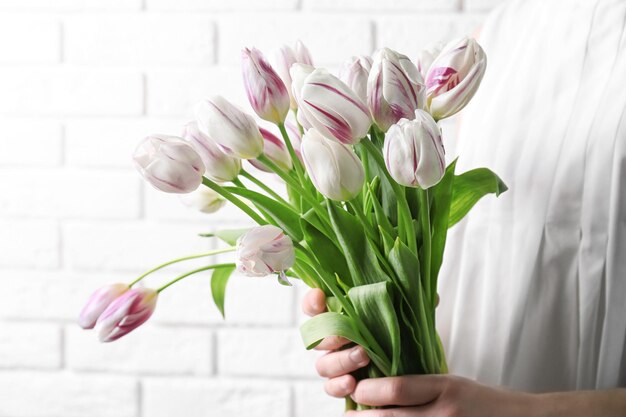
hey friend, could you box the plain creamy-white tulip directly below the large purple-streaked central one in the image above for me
[302,129,365,201]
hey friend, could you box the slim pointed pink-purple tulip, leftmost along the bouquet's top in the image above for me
[241,48,289,124]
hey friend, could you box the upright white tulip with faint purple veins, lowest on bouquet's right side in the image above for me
[383,110,446,189]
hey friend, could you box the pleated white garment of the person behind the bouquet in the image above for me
[437,0,626,392]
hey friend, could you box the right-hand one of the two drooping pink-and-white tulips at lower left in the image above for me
[96,288,158,342]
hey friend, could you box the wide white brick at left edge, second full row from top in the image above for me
[0,67,143,116]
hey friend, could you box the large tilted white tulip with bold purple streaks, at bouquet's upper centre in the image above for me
[291,64,372,145]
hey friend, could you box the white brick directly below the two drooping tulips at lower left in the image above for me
[65,322,213,375]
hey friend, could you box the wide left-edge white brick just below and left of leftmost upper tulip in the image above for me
[0,169,141,219]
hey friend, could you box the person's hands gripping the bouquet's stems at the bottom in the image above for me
[302,289,535,417]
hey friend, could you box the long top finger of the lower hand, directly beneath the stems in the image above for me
[352,375,445,406]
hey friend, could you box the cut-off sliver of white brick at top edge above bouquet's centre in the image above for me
[303,0,460,12]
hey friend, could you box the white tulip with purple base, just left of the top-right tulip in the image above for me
[367,48,425,132]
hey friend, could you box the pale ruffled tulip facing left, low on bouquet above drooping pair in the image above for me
[237,225,296,278]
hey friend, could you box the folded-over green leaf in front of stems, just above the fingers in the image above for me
[348,281,402,375]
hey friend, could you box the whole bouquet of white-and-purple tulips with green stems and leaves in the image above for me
[80,38,506,408]
